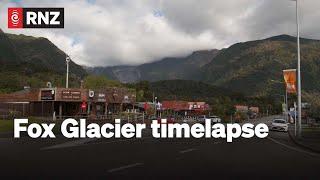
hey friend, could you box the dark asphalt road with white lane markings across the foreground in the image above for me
[0,118,320,179]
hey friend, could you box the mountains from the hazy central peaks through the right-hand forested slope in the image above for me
[89,35,320,95]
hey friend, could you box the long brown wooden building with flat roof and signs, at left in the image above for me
[0,87,136,118]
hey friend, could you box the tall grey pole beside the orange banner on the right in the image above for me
[296,0,301,137]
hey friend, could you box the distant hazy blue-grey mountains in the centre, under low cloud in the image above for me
[87,49,219,83]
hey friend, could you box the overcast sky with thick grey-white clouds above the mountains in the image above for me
[0,0,320,66]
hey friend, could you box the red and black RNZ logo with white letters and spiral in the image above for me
[8,8,64,28]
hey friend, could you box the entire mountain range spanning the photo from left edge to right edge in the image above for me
[0,30,320,96]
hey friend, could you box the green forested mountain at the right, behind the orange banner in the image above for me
[201,35,320,95]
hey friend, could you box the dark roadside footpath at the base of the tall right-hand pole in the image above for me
[288,125,320,153]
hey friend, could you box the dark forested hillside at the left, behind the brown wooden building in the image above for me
[0,29,87,92]
